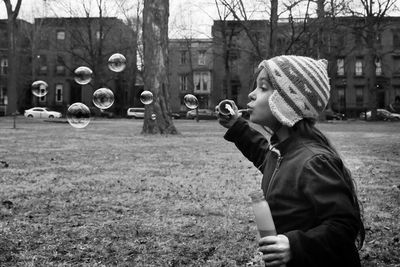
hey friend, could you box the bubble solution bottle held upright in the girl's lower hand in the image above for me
[249,190,276,238]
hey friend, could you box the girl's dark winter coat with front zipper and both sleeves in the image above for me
[225,118,361,267]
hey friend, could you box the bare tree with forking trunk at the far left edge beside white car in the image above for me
[4,0,22,113]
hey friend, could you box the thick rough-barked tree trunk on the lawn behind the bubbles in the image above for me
[142,0,178,134]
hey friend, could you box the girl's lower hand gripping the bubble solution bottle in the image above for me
[258,235,291,266]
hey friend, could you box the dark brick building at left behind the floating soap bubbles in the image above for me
[32,17,137,115]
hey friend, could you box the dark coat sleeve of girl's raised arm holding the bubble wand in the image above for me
[224,118,269,171]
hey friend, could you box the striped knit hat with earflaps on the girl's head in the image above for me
[259,56,330,127]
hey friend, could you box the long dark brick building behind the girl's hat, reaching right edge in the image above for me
[212,17,400,117]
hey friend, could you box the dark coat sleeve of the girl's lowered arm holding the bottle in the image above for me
[284,155,361,266]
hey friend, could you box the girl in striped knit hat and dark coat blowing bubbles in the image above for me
[218,56,365,267]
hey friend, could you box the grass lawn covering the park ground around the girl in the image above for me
[0,117,400,266]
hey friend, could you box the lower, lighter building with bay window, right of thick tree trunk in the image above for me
[168,39,214,113]
